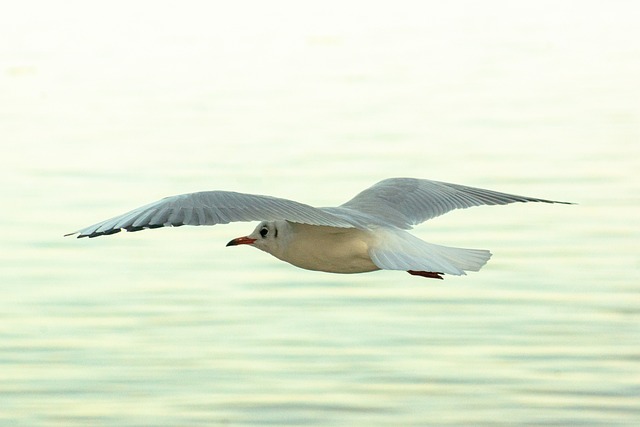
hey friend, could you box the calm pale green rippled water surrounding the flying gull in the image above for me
[0,1,640,426]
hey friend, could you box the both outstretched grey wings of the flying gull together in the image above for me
[68,178,566,237]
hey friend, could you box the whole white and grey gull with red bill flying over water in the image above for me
[66,178,571,279]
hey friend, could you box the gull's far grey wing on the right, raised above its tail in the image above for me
[336,178,571,229]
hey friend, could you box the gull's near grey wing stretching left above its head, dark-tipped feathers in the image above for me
[67,191,357,238]
